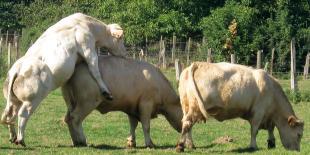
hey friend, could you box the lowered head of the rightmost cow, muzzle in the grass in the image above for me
[279,116,304,151]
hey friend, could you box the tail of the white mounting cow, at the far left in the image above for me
[1,70,17,124]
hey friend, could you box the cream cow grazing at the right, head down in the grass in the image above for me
[176,62,304,152]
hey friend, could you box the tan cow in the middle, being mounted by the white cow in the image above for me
[62,56,188,147]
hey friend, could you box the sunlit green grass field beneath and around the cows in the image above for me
[0,71,310,154]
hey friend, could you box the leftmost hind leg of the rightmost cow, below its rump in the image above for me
[176,113,194,152]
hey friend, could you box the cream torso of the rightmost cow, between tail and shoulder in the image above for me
[183,63,273,121]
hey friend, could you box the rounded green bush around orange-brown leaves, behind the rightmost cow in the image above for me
[200,1,258,62]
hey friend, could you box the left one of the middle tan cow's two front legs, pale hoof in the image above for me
[127,115,138,148]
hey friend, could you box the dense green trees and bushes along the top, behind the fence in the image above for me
[0,0,310,71]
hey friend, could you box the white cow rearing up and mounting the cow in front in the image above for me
[1,13,126,146]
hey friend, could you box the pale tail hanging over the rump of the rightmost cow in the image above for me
[189,63,208,119]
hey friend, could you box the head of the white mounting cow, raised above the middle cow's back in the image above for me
[100,24,127,57]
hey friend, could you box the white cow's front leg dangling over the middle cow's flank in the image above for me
[82,48,113,100]
